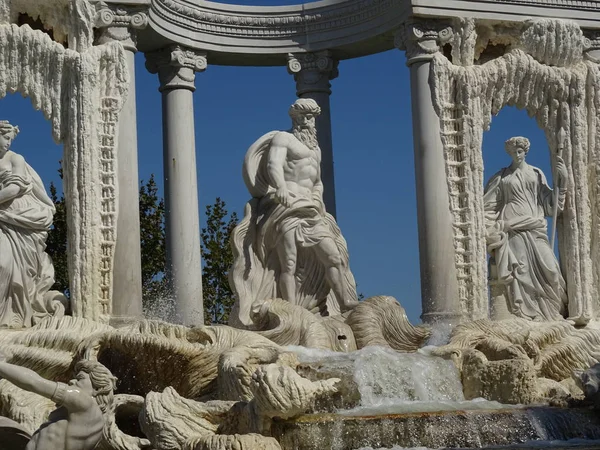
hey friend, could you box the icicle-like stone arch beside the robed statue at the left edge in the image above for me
[0,5,129,321]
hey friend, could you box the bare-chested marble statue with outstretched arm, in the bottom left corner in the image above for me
[0,353,115,450]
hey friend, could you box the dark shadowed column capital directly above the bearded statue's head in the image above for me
[288,50,338,96]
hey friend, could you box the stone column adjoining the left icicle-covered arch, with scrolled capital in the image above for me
[96,4,148,326]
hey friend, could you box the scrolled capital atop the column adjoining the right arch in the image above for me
[394,19,453,66]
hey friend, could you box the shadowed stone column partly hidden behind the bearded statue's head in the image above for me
[288,51,338,217]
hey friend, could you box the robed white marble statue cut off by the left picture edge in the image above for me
[0,121,64,328]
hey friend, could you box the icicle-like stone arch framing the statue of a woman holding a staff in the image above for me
[431,19,600,322]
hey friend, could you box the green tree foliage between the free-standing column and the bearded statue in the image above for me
[201,197,238,325]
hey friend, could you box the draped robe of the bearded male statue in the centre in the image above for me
[229,131,357,327]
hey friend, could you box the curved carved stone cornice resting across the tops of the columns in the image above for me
[125,0,600,65]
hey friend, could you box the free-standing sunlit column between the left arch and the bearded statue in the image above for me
[146,46,207,326]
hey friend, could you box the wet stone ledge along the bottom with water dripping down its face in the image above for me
[271,407,600,450]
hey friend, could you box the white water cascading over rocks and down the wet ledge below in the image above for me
[280,347,600,450]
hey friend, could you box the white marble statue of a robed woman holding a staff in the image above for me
[484,137,567,321]
